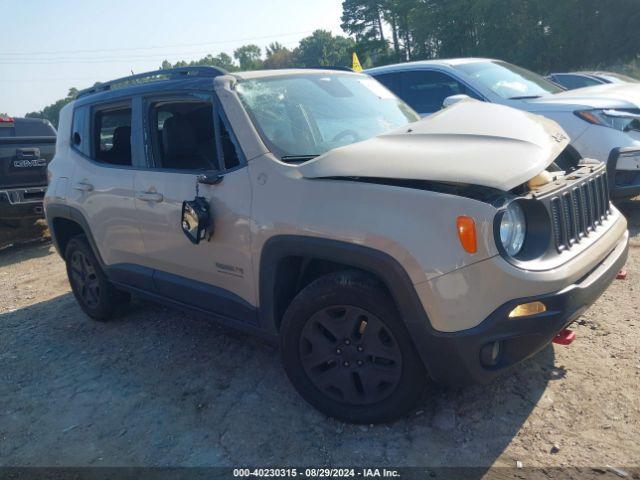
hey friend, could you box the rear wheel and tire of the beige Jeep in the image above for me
[64,235,131,321]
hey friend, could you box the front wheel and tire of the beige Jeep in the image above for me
[281,271,428,423]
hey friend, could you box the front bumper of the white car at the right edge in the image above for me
[607,147,640,198]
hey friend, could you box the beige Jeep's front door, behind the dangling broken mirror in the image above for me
[135,93,257,323]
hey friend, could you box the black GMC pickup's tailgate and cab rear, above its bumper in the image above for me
[0,118,56,189]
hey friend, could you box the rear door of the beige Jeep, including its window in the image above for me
[69,98,151,278]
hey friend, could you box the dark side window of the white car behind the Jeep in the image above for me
[396,71,478,113]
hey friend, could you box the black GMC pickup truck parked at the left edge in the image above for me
[0,117,56,224]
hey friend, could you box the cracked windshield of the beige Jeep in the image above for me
[236,73,420,162]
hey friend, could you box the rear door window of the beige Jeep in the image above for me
[92,105,131,166]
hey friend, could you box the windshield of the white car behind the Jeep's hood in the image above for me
[456,62,563,100]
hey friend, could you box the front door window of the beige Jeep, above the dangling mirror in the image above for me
[149,99,240,170]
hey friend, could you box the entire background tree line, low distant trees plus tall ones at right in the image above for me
[26,0,640,127]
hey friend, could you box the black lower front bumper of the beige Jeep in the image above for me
[419,235,628,386]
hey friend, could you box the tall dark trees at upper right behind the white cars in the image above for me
[342,0,640,73]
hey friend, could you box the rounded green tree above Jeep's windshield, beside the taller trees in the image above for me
[295,30,356,67]
